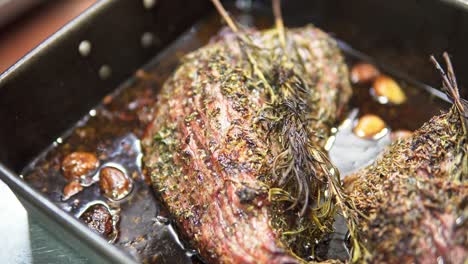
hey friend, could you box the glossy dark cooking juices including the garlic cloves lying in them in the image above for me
[22,10,447,263]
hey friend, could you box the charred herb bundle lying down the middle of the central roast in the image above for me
[213,0,367,261]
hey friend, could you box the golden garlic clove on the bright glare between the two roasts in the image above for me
[353,114,387,139]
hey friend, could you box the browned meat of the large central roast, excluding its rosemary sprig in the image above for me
[143,26,351,263]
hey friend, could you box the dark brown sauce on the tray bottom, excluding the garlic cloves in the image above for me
[23,8,445,263]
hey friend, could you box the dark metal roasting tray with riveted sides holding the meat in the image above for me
[0,0,468,263]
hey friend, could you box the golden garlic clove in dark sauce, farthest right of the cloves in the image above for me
[373,75,406,104]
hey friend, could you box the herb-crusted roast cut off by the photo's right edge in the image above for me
[345,54,468,263]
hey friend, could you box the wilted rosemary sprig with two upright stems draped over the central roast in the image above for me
[208,0,368,262]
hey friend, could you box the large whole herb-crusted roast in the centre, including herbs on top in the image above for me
[142,17,351,263]
